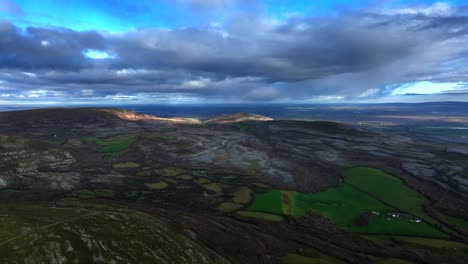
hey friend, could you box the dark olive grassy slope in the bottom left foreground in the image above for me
[0,204,224,263]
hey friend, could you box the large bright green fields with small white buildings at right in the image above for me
[248,168,448,238]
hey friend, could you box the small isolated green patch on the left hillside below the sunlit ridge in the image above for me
[82,135,137,153]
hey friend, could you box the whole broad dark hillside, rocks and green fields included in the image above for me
[0,108,468,263]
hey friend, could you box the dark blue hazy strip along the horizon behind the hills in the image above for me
[0,102,468,122]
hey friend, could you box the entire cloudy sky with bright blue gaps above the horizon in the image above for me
[0,0,468,105]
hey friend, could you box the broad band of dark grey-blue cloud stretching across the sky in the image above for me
[0,2,468,100]
